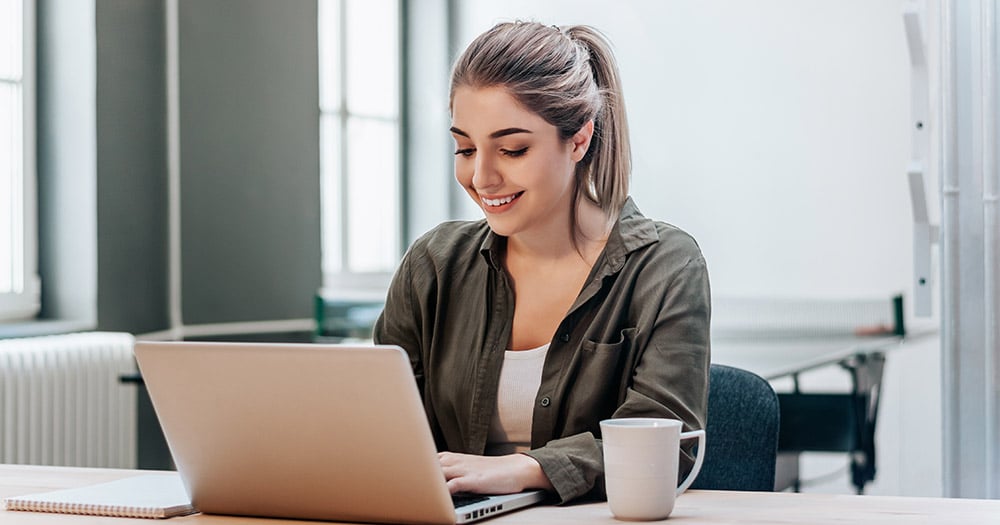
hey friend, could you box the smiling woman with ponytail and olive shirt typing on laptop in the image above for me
[374,22,710,502]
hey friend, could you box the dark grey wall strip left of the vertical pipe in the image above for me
[96,0,167,332]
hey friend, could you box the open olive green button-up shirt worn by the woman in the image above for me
[374,199,711,502]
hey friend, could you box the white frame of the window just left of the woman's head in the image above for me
[317,0,407,297]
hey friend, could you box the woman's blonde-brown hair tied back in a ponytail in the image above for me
[449,22,632,223]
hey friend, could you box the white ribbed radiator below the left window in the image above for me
[0,332,136,468]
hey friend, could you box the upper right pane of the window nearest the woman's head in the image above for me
[345,0,399,118]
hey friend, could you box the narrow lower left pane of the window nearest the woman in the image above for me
[319,115,344,274]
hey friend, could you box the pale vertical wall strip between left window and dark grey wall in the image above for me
[36,0,97,326]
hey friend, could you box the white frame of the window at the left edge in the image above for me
[0,0,41,321]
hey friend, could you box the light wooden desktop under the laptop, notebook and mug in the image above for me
[0,465,1000,525]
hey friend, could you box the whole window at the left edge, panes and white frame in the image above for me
[0,0,39,320]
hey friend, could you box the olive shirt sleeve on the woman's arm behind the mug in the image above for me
[526,254,711,503]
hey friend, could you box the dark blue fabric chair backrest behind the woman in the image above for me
[691,364,780,491]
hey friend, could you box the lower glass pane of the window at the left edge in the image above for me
[0,84,16,293]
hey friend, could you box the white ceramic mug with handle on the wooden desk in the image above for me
[601,418,705,520]
